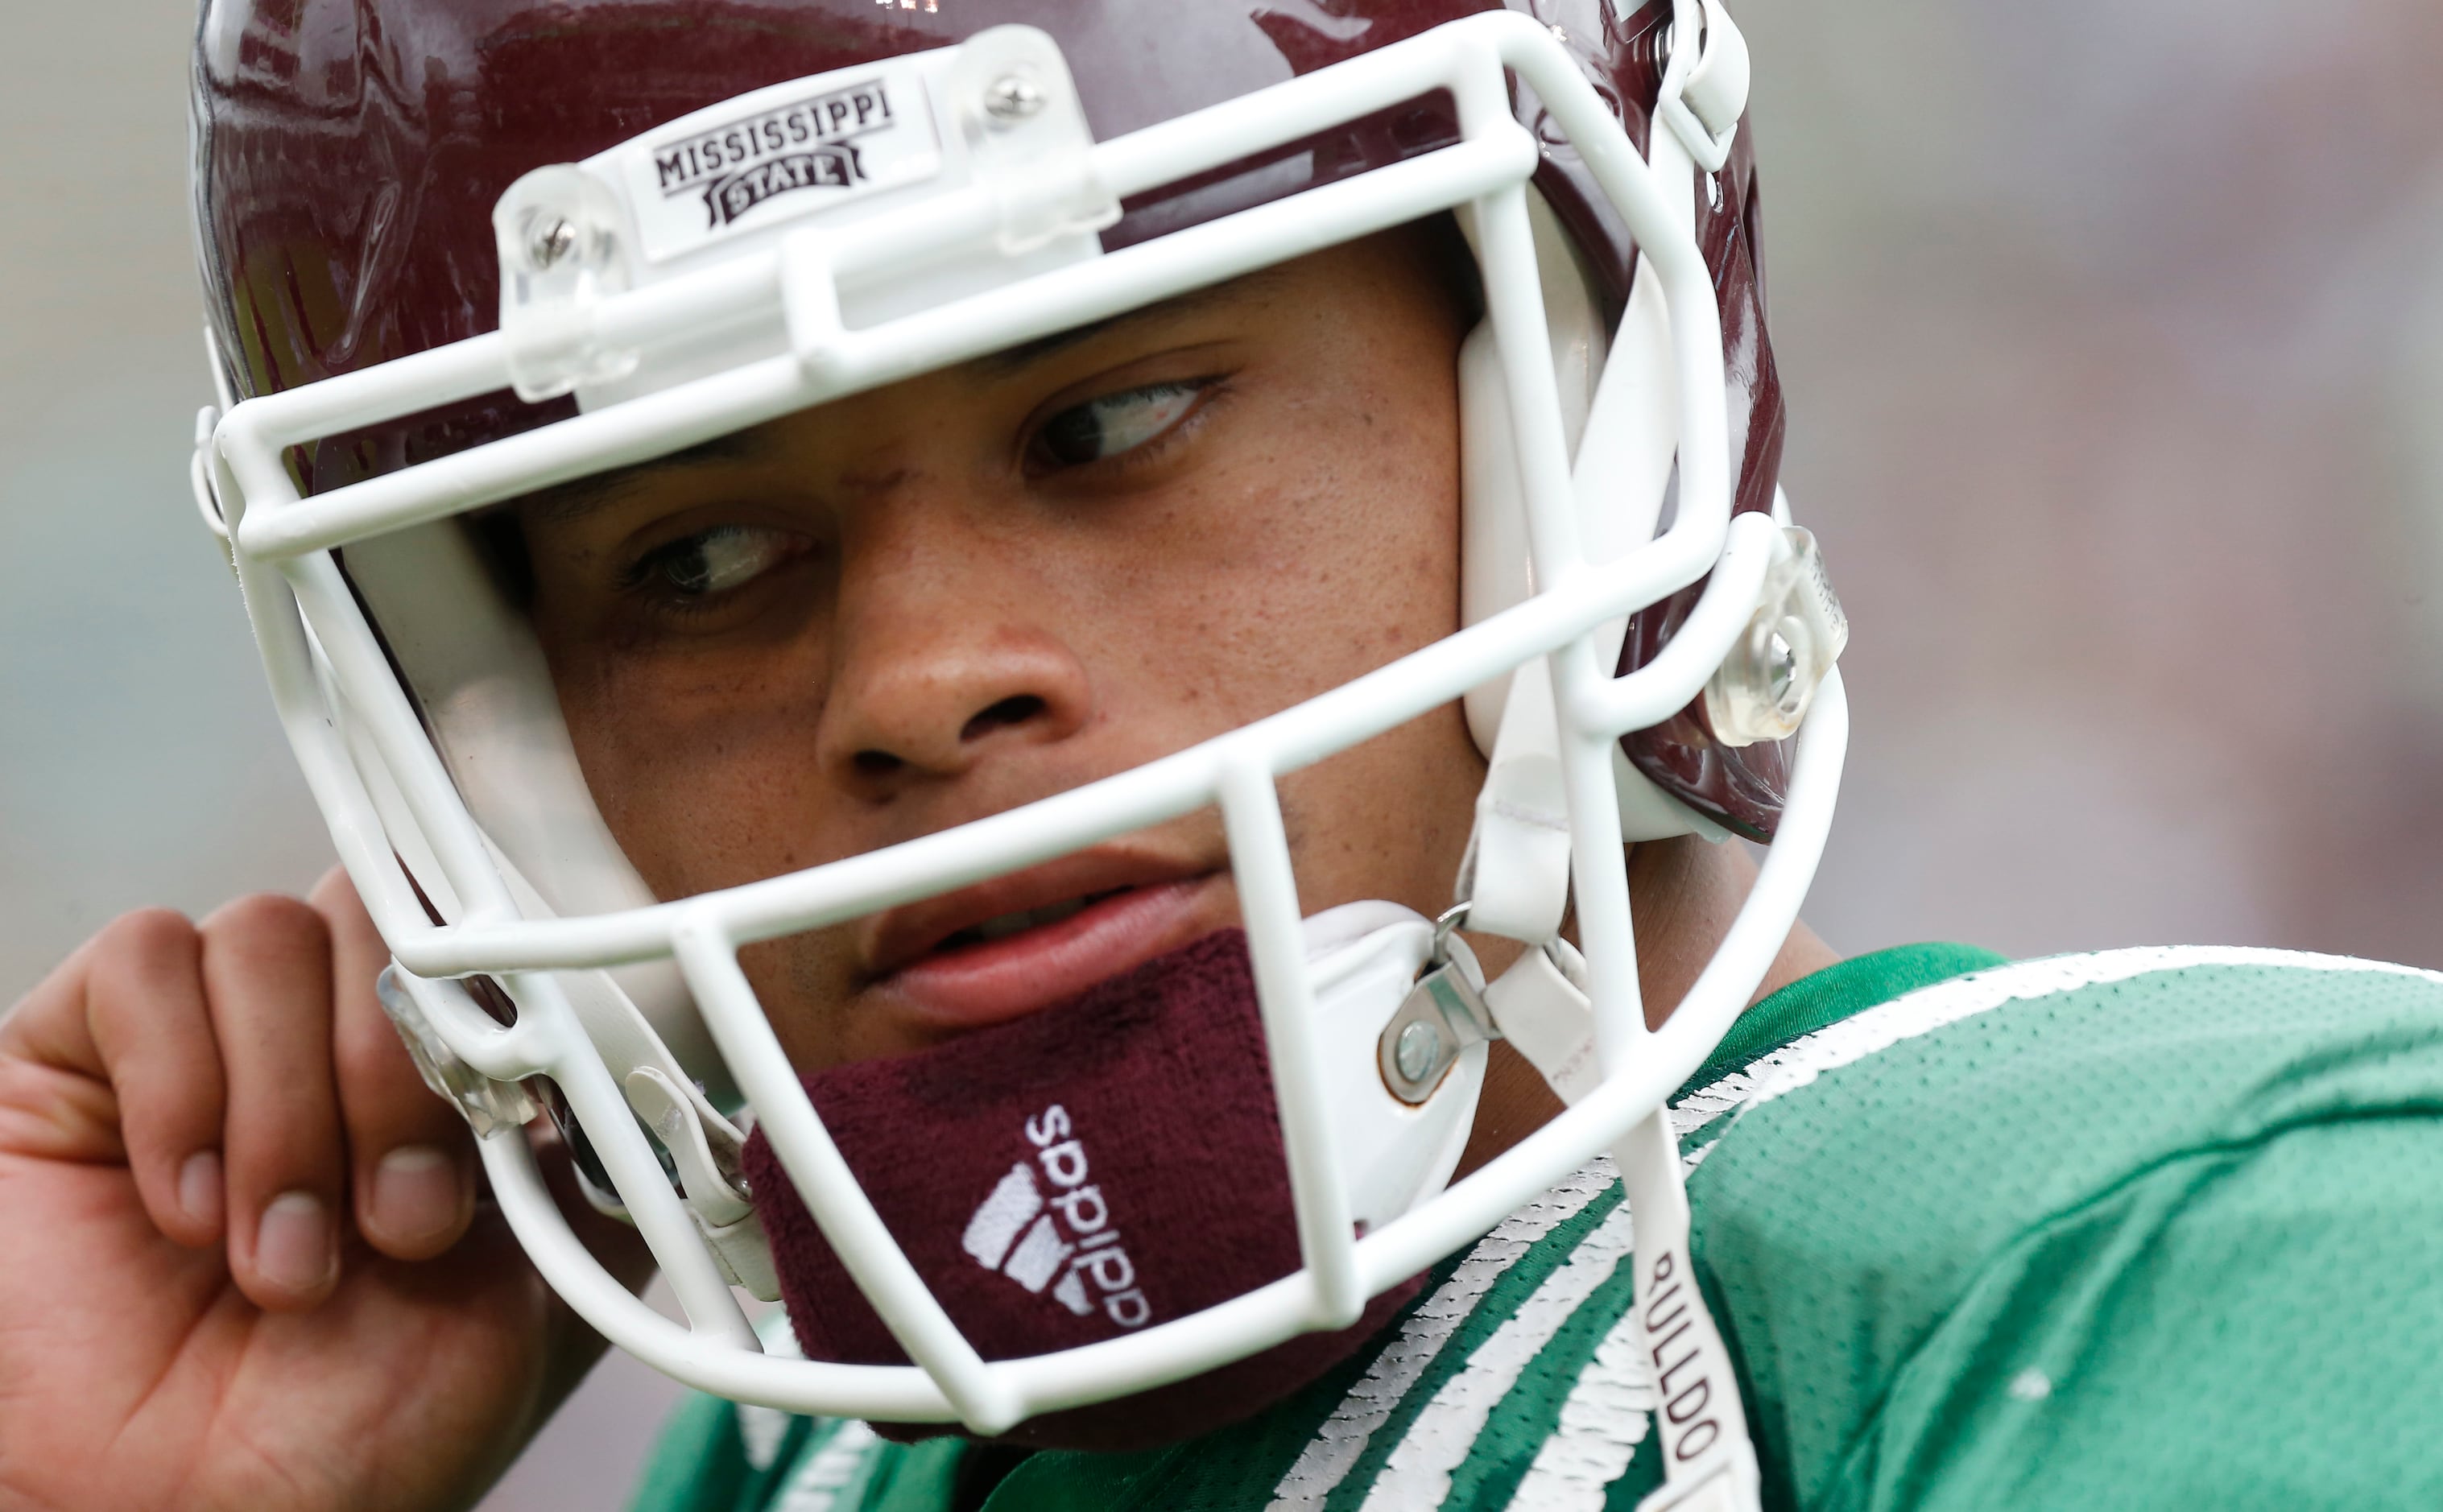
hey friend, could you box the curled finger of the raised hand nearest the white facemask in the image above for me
[312,870,474,1261]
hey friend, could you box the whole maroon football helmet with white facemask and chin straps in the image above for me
[193,0,1847,1495]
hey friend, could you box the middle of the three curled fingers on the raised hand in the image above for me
[203,896,347,1309]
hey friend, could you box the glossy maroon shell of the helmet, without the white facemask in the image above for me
[196,0,1788,841]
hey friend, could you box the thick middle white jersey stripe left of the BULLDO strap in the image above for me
[1366,1202,1637,1512]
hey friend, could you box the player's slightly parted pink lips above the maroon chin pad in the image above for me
[860,848,1229,1033]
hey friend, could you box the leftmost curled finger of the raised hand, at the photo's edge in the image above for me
[0,909,222,1246]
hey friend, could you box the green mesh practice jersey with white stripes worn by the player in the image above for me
[635,945,2443,1512]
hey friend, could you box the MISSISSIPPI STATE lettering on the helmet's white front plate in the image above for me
[652,78,894,227]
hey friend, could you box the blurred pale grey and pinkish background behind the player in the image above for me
[0,0,2443,1512]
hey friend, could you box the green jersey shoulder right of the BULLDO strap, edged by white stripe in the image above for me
[1676,948,2443,1507]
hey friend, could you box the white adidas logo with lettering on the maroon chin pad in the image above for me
[960,1104,1153,1328]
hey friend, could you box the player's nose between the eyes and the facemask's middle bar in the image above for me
[818,508,1092,801]
